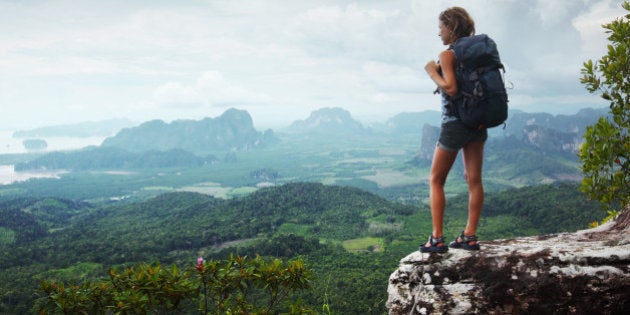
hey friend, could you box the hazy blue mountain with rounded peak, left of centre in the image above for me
[102,109,277,153]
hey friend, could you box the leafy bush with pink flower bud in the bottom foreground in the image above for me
[35,257,311,314]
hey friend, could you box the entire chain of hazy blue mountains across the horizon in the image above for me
[15,108,607,183]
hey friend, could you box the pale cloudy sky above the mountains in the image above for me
[0,0,625,130]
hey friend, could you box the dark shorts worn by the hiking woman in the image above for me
[438,119,488,152]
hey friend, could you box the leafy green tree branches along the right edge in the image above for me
[580,1,630,213]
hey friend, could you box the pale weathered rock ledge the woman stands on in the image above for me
[387,207,630,314]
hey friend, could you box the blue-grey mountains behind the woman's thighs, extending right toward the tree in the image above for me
[407,109,607,184]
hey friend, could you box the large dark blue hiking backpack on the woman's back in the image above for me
[448,34,508,129]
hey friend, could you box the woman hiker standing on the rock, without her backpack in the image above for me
[420,7,488,253]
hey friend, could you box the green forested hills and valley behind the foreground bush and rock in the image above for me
[0,183,602,314]
